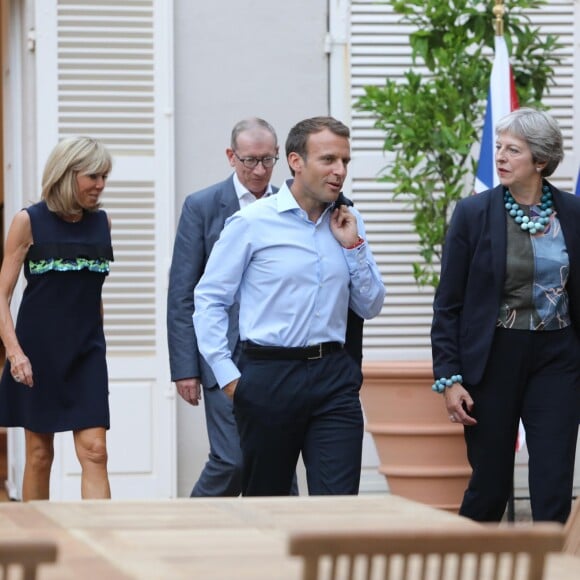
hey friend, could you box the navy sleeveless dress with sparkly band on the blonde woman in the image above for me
[0,202,113,433]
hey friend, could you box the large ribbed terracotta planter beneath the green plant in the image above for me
[361,361,471,510]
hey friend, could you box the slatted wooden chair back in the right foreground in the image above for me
[289,523,564,580]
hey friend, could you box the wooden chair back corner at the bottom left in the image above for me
[0,540,57,580]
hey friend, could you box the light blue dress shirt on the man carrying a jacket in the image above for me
[193,181,385,387]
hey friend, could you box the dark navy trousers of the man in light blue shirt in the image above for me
[234,350,363,496]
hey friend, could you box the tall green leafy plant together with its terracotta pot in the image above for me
[355,0,560,509]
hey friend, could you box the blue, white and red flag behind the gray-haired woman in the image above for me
[474,36,518,193]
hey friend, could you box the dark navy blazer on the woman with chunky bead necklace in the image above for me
[431,185,580,385]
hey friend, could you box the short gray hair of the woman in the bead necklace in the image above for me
[495,107,564,177]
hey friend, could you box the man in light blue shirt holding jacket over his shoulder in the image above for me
[193,117,385,495]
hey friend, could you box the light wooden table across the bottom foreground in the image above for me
[0,495,580,580]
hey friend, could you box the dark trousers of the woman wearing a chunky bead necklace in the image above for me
[459,327,580,523]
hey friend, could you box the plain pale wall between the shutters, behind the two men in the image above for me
[168,0,328,496]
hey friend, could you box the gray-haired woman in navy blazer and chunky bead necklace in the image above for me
[431,109,580,522]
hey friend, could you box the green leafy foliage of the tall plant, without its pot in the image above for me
[356,0,562,287]
